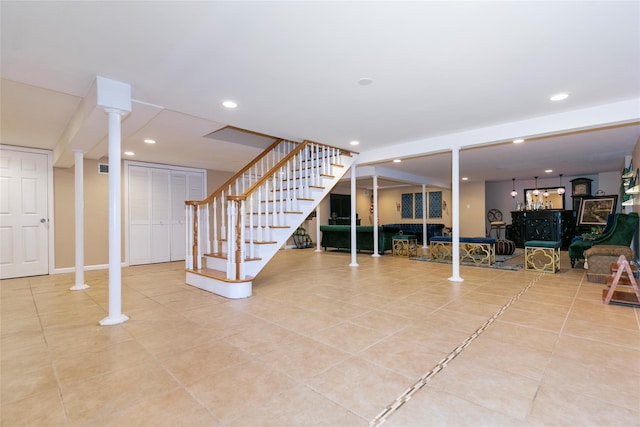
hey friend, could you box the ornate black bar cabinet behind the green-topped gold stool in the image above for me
[510,210,576,248]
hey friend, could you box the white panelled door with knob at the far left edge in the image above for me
[0,149,49,279]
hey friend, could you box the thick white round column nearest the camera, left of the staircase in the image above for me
[100,108,129,326]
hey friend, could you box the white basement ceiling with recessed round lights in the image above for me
[0,0,640,186]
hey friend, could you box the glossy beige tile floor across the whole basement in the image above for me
[0,249,640,426]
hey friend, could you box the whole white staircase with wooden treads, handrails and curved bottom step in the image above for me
[185,140,356,298]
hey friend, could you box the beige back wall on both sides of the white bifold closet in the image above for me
[53,159,233,269]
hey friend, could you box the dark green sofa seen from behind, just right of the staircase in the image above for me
[320,225,400,255]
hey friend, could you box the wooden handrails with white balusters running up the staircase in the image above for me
[186,141,352,280]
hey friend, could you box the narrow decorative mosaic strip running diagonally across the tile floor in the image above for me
[369,273,545,427]
